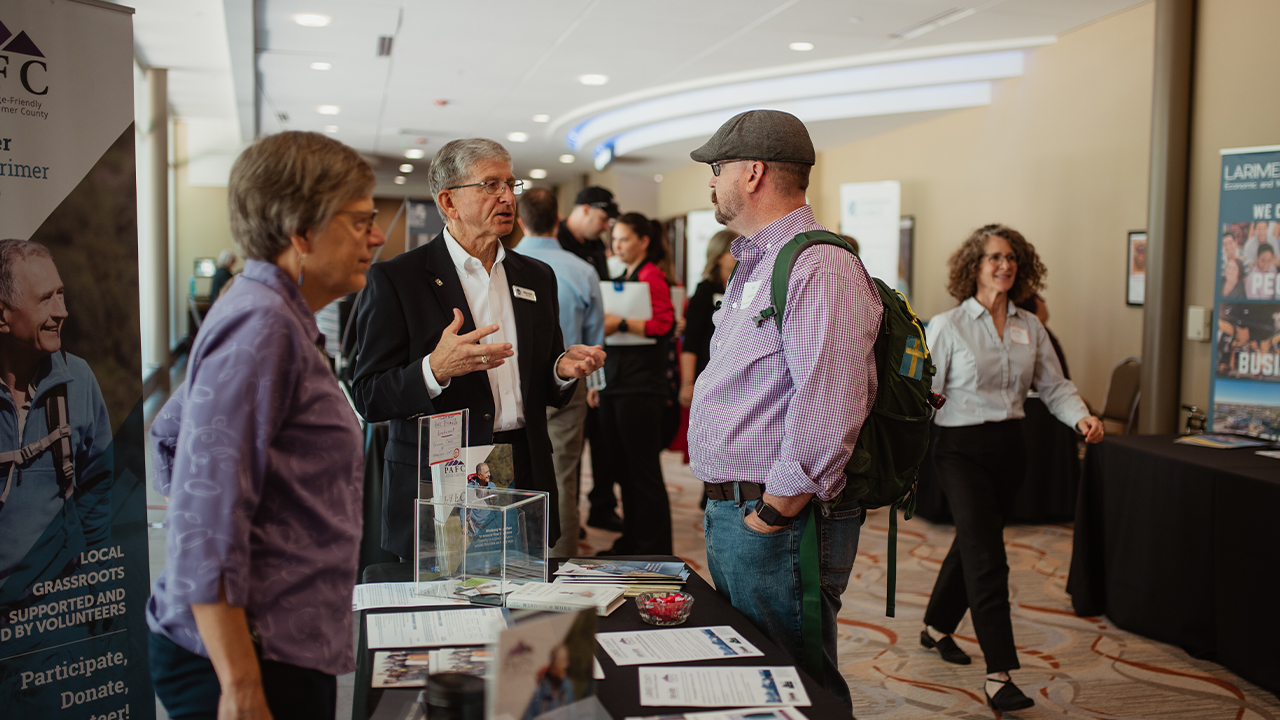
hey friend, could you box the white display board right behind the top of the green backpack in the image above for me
[840,181,909,287]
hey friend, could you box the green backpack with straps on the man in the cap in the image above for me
[756,231,946,618]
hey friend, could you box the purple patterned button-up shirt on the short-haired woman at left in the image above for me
[147,260,364,675]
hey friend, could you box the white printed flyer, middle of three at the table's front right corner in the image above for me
[640,666,812,707]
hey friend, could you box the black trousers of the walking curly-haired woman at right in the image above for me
[924,420,1027,673]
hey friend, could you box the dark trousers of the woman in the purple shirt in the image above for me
[147,633,338,720]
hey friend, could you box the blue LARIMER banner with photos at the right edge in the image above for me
[1208,145,1280,439]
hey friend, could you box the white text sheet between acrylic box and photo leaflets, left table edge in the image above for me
[366,607,506,650]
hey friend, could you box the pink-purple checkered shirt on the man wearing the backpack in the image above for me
[689,205,883,500]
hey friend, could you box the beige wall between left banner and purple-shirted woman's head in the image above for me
[173,122,235,337]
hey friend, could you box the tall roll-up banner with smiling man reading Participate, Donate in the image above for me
[0,0,155,720]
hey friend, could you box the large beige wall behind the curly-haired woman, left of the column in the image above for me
[659,4,1155,405]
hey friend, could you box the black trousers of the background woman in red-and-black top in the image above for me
[594,395,671,555]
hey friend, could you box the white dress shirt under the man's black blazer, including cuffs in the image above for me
[422,227,573,433]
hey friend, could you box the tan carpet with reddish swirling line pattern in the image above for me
[582,452,1280,720]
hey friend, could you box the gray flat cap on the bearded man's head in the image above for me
[689,110,814,165]
